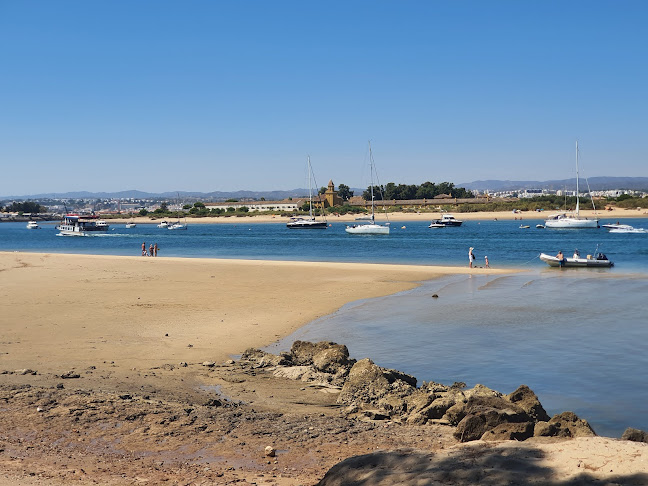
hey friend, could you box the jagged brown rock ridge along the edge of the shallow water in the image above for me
[242,341,604,442]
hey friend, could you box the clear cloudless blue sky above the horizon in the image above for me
[0,0,648,196]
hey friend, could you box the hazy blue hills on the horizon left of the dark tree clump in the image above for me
[0,188,364,201]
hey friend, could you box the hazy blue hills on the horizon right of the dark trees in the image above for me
[457,177,648,191]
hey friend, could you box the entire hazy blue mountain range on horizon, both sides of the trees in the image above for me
[0,177,648,201]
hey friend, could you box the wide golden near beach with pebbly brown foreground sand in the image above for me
[0,252,648,485]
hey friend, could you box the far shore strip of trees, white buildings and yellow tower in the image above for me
[0,181,648,221]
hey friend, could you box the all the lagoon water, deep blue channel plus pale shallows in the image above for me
[0,219,648,436]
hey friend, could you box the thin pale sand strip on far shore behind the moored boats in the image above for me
[104,208,648,224]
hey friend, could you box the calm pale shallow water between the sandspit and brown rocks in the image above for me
[269,272,648,436]
